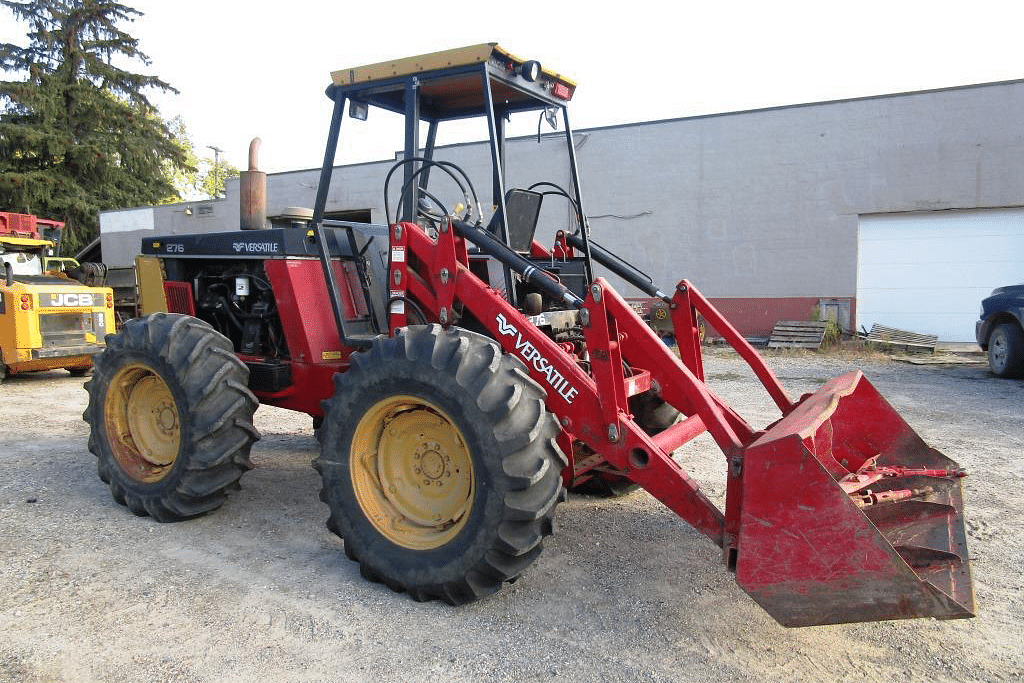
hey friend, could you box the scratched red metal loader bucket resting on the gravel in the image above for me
[735,372,975,627]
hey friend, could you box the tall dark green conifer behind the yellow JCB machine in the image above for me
[0,0,188,252]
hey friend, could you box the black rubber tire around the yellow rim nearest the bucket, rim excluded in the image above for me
[313,325,567,605]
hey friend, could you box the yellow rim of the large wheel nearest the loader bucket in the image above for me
[349,395,475,550]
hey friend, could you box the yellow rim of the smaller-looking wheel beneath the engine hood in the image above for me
[103,365,181,483]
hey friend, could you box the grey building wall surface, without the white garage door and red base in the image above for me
[103,81,1024,334]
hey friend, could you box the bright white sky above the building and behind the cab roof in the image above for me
[0,0,1024,172]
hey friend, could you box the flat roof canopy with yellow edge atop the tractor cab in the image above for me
[328,43,575,121]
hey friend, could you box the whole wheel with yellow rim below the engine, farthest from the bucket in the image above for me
[82,313,259,522]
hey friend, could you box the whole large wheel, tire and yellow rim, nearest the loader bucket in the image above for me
[313,326,566,604]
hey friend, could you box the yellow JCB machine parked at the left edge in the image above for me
[0,212,114,382]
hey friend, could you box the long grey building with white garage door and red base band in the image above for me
[100,81,1024,341]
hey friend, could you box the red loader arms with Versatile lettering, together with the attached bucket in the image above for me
[390,216,974,626]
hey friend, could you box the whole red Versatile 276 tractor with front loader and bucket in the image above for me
[85,44,974,626]
